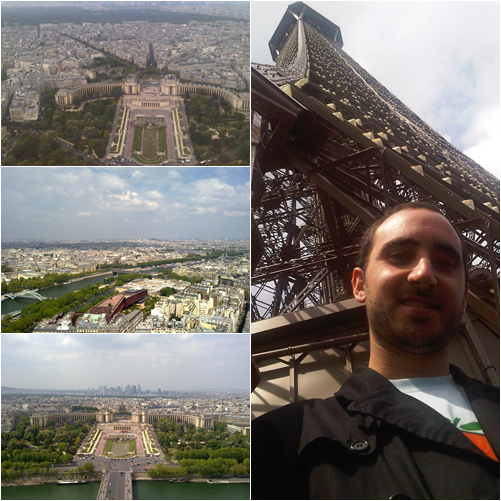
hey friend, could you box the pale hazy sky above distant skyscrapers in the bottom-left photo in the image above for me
[2,334,250,391]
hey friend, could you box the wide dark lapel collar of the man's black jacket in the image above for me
[299,366,499,457]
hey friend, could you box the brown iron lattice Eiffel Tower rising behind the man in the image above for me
[251,2,500,400]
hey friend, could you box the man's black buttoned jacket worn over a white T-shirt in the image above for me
[251,365,499,499]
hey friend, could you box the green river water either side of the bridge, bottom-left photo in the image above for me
[2,481,250,500]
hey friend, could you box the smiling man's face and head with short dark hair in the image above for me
[353,208,467,354]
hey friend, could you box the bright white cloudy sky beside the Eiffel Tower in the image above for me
[251,0,501,178]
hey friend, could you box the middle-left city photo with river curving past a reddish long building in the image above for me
[1,167,250,333]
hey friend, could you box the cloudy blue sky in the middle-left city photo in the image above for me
[1,167,250,241]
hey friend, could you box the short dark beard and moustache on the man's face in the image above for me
[365,284,463,355]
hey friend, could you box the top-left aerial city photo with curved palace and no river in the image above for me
[1,1,250,166]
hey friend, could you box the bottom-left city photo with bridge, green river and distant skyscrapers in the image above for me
[1,334,250,500]
